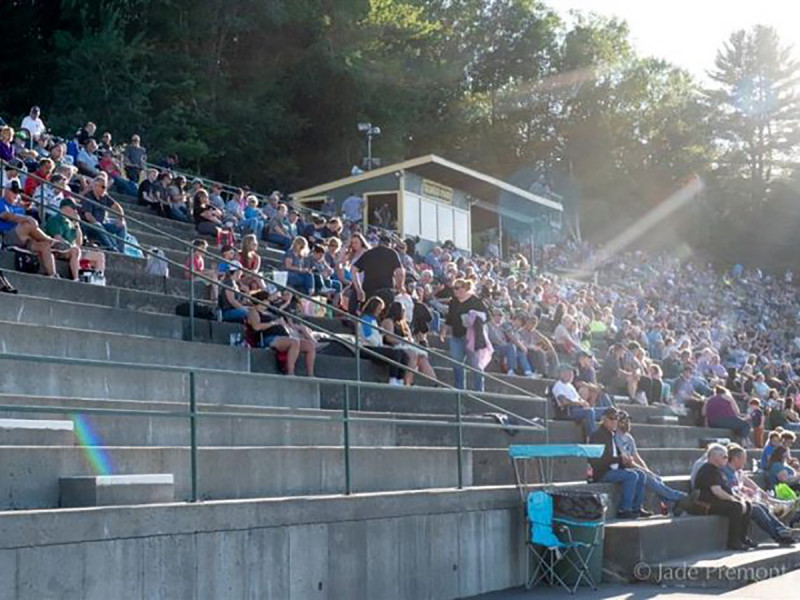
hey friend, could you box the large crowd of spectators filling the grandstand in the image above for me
[0,107,800,549]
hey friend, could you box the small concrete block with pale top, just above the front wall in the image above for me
[59,473,175,508]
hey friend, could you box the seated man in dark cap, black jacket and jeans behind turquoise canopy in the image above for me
[589,407,652,519]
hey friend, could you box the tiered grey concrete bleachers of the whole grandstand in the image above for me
[0,189,800,598]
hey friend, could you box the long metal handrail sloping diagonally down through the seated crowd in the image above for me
[0,161,547,425]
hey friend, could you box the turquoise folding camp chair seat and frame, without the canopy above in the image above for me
[525,491,604,594]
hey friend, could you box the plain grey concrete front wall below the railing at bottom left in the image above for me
[0,489,524,600]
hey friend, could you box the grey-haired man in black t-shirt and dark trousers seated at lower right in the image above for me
[694,444,758,550]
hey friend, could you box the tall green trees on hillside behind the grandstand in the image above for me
[0,0,800,268]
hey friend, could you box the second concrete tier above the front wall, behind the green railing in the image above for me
[0,396,544,448]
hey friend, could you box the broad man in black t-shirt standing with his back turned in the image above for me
[350,236,406,306]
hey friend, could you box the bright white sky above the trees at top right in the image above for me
[545,0,800,79]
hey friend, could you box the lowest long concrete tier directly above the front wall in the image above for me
[0,446,473,509]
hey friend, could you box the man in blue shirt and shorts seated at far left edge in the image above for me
[0,181,56,277]
